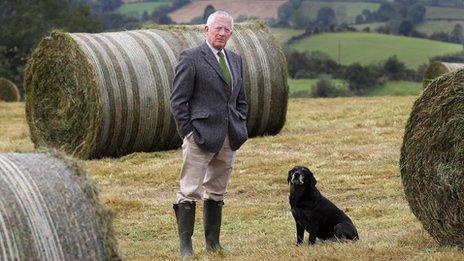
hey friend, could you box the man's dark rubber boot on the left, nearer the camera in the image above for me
[173,202,195,258]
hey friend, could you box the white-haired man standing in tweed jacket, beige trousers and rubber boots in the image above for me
[171,11,248,257]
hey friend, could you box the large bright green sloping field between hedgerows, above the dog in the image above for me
[291,33,462,68]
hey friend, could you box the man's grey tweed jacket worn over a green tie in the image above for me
[170,42,248,153]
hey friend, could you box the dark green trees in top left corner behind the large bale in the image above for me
[0,0,100,91]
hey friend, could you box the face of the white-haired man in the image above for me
[205,17,232,51]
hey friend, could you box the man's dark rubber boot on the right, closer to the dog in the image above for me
[203,199,224,251]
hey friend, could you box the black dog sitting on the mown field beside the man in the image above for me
[287,166,358,244]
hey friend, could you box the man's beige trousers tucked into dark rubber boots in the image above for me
[176,133,235,203]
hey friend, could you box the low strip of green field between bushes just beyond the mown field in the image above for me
[288,79,423,96]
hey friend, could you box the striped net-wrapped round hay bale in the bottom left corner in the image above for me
[0,153,120,260]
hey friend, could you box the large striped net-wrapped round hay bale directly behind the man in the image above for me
[25,20,288,158]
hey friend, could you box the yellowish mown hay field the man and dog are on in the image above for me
[0,96,464,260]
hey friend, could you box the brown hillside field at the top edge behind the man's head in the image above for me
[168,0,286,23]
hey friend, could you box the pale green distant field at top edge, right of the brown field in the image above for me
[301,1,380,23]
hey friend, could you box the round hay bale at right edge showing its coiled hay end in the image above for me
[400,67,464,247]
